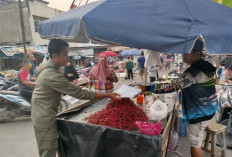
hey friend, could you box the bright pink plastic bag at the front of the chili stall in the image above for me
[135,121,161,135]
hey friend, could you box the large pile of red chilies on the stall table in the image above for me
[88,98,148,130]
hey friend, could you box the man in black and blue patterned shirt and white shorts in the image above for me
[179,39,218,157]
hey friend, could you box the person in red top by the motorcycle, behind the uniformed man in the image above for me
[18,61,35,100]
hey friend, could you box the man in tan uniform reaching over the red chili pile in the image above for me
[31,39,119,157]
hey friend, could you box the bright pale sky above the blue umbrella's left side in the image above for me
[44,0,96,11]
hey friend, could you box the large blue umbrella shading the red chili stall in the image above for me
[40,0,232,54]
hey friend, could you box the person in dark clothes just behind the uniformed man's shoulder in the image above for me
[64,61,79,84]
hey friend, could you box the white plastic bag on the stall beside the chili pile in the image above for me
[149,100,167,121]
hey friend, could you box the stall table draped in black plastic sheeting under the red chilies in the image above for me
[58,84,179,157]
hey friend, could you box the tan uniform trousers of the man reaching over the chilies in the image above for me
[34,126,58,157]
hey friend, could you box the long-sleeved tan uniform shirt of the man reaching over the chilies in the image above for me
[31,60,95,128]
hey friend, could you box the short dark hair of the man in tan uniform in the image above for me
[48,39,69,58]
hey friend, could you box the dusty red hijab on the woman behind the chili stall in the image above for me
[90,55,113,83]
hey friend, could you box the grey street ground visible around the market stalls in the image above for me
[0,66,232,157]
